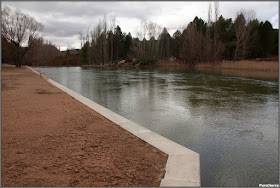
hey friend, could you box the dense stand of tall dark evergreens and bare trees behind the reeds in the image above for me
[80,3,278,64]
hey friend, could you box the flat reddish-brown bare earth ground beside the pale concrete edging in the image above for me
[1,67,167,187]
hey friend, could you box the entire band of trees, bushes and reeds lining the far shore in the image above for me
[1,3,279,72]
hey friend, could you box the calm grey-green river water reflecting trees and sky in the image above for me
[35,67,279,187]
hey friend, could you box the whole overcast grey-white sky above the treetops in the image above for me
[2,1,279,50]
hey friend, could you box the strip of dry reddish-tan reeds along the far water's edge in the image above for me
[82,60,279,80]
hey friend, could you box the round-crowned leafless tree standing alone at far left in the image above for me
[1,7,43,67]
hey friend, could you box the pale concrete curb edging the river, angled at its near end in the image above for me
[28,67,201,187]
